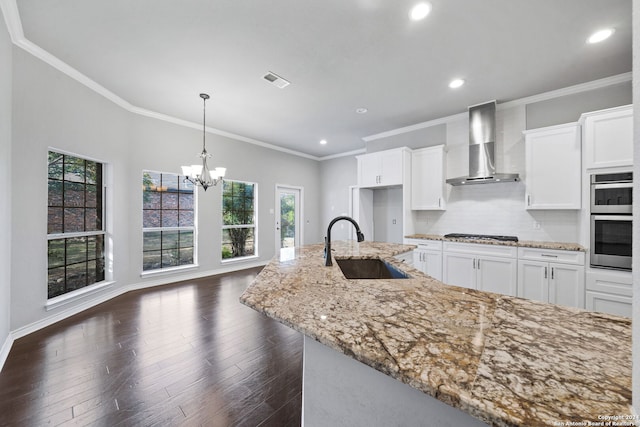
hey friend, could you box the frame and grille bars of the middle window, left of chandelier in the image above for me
[140,169,198,277]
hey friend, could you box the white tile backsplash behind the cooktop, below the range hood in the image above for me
[415,182,583,243]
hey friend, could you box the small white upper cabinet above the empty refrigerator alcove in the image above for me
[356,148,408,187]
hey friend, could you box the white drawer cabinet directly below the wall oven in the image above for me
[586,269,633,317]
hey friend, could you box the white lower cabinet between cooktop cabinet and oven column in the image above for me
[518,248,585,308]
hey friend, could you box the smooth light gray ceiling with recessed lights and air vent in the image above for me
[7,0,632,158]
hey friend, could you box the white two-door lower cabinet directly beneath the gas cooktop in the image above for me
[442,242,518,296]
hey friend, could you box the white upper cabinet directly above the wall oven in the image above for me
[580,105,633,169]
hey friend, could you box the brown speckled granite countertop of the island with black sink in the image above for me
[240,242,631,426]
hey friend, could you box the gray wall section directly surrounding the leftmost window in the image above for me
[11,48,132,330]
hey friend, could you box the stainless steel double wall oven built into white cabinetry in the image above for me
[591,172,633,270]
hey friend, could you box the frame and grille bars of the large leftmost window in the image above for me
[45,147,112,300]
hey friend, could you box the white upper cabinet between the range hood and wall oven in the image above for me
[524,123,582,209]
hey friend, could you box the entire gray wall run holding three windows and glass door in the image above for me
[8,48,322,331]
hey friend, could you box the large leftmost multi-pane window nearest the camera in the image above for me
[47,151,105,298]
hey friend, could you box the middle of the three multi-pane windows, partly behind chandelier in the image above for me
[142,171,195,271]
